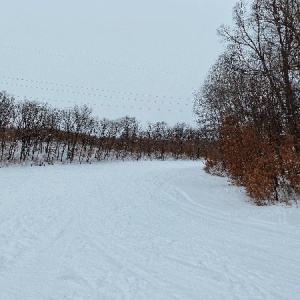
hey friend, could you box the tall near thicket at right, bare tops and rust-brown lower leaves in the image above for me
[195,0,300,204]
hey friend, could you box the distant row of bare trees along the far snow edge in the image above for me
[0,92,209,165]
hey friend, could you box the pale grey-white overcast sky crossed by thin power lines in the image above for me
[0,0,236,125]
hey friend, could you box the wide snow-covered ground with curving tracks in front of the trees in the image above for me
[0,161,300,300]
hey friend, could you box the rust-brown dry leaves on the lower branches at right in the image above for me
[206,117,300,205]
